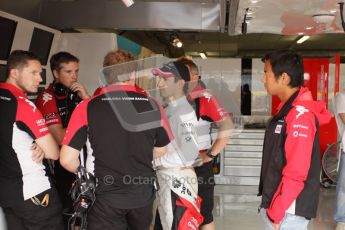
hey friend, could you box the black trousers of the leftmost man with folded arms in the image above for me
[3,189,63,230]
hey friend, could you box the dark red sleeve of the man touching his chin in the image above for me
[36,92,62,126]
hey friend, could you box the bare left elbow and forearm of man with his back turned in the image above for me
[60,145,80,173]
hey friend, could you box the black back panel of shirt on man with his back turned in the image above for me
[83,91,169,209]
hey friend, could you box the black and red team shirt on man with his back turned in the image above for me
[63,85,173,209]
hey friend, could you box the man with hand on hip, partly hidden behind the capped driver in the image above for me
[177,57,233,230]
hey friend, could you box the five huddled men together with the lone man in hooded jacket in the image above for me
[0,47,342,230]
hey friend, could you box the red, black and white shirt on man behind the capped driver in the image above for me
[188,83,228,150]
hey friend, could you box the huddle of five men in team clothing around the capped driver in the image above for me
[0,50,232,229]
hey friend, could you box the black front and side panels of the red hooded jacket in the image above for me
[258,91,320,218]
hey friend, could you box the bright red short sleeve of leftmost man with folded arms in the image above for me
[16,97,49,139]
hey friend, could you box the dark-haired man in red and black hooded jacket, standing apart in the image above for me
[259,50,331,230]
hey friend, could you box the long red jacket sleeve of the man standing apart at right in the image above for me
[267,106,316,223]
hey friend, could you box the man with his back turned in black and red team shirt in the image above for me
[60,52,172,230]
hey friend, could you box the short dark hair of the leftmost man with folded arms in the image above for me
[6,50,40,78]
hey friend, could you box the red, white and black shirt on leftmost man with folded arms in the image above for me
[0,83,50,207]
